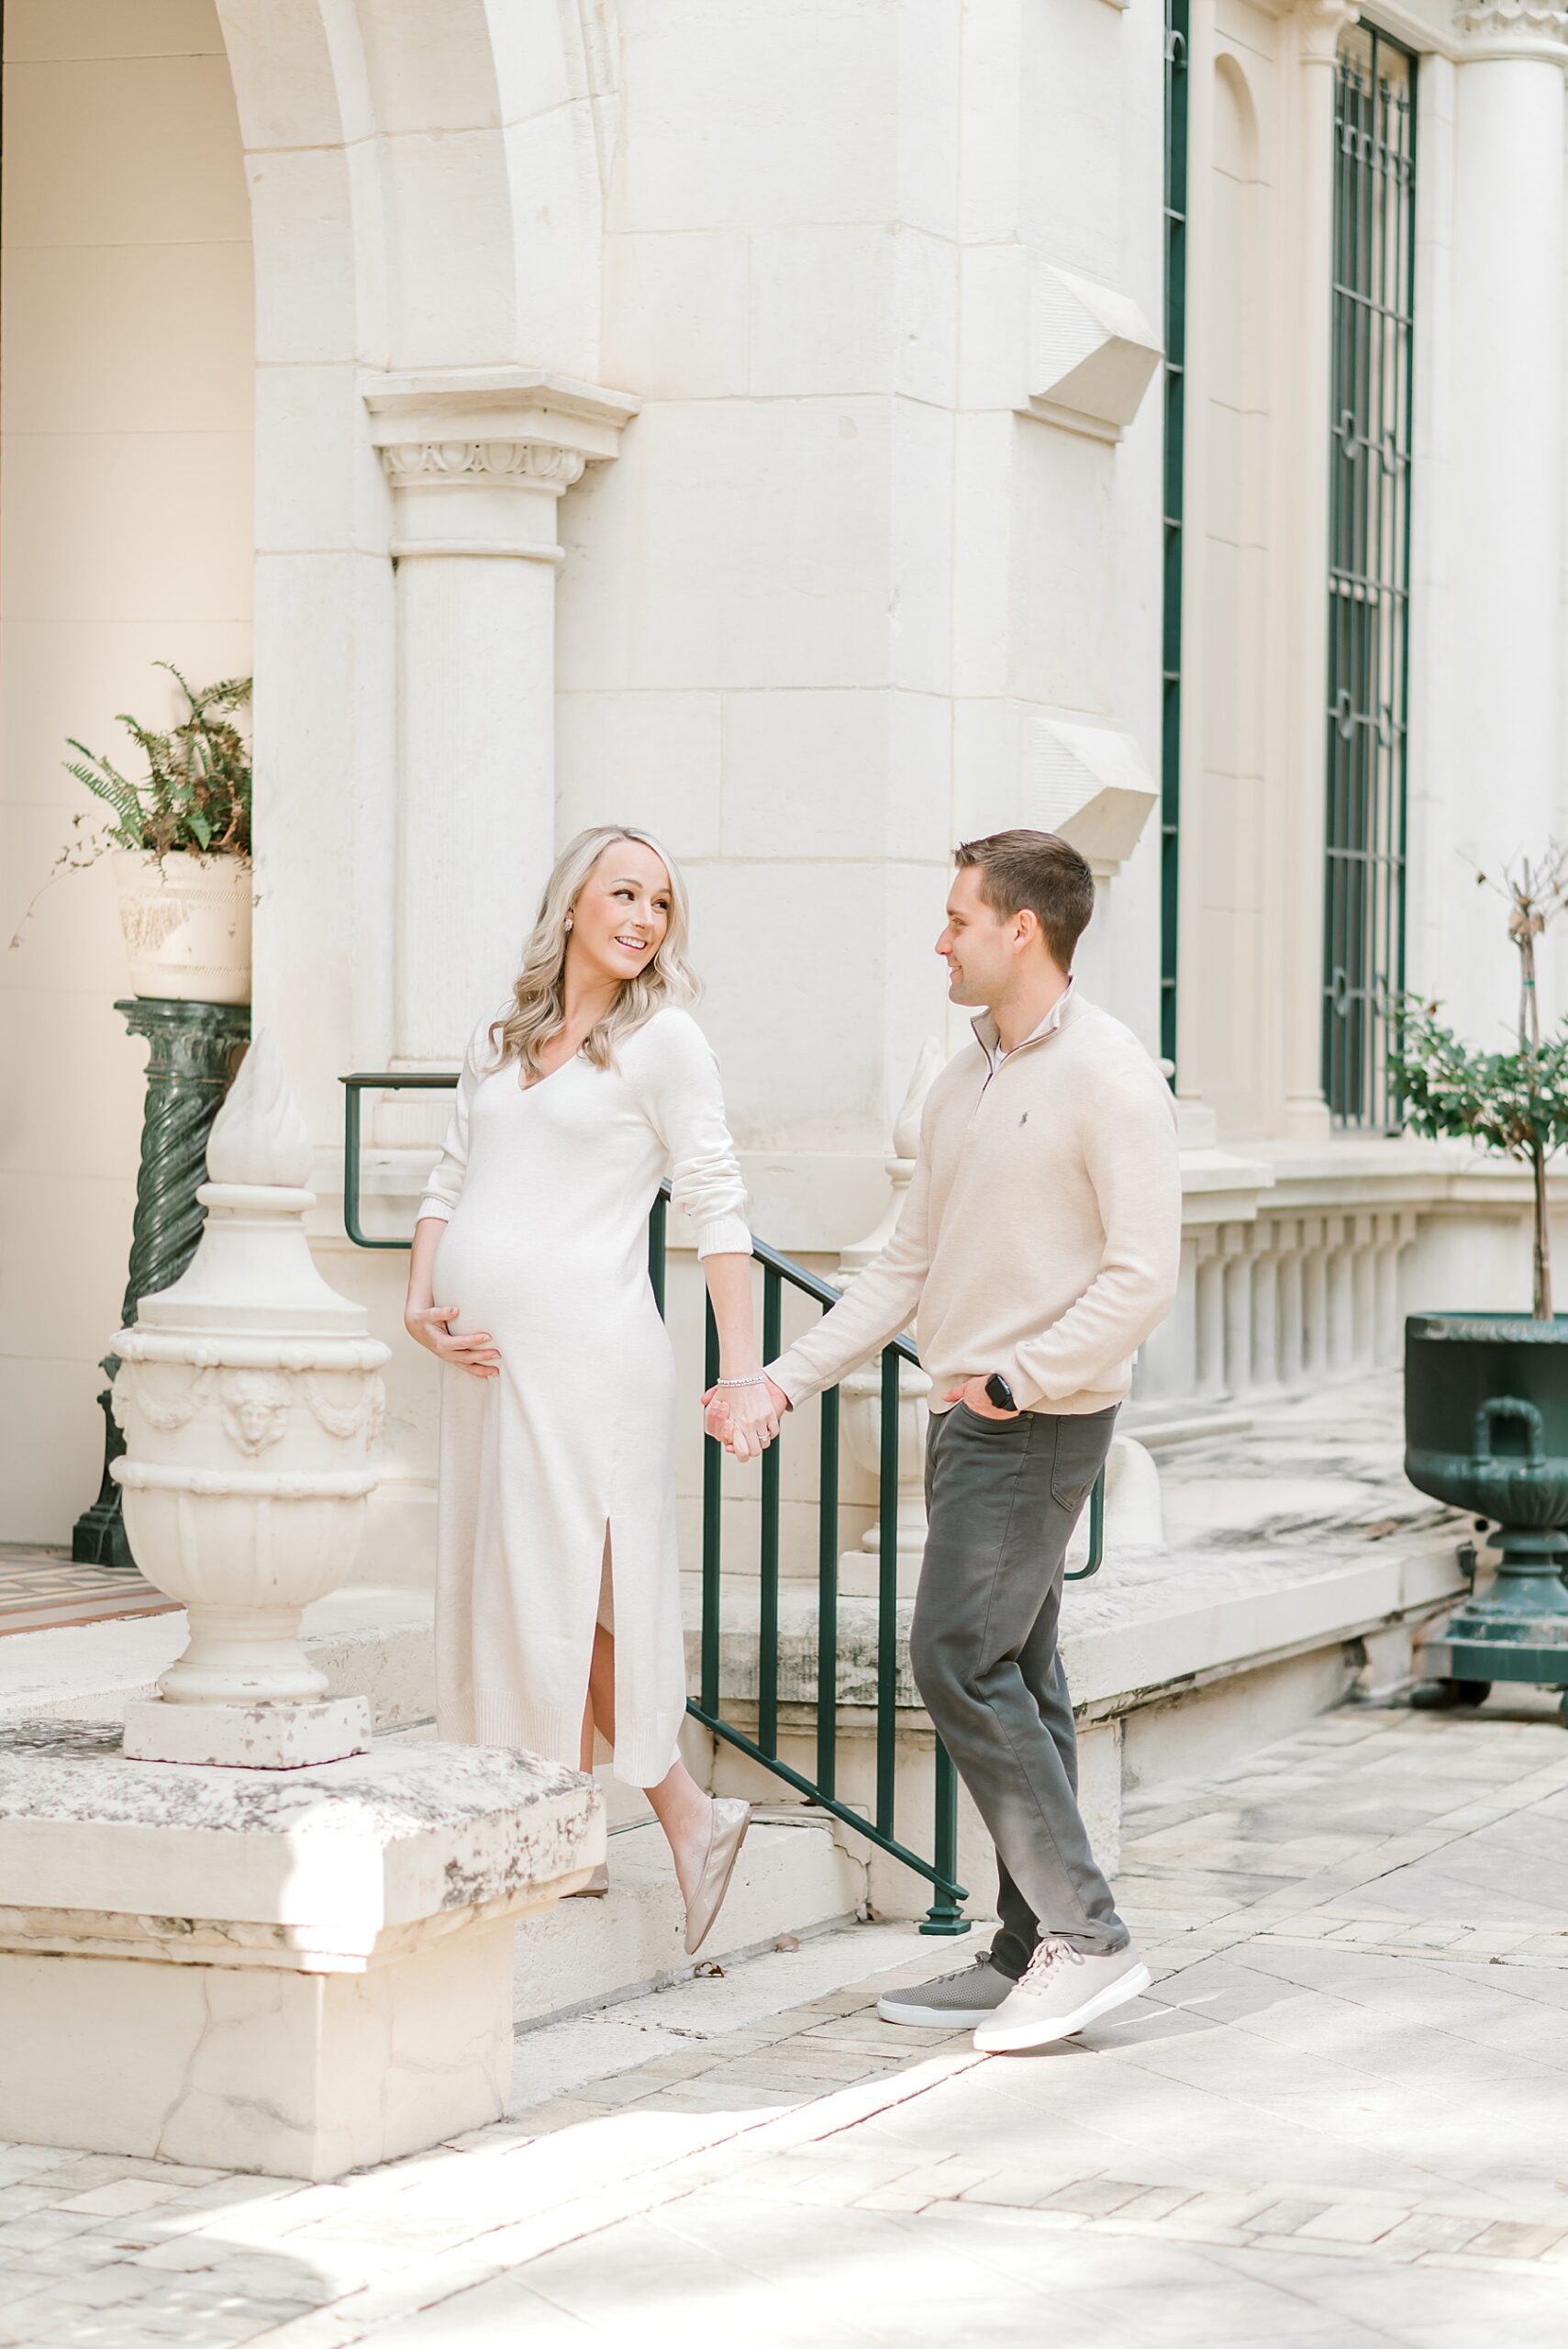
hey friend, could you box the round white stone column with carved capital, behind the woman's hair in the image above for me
[366,369,636,1089]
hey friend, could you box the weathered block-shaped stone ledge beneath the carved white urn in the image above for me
[0,1720,604,2177]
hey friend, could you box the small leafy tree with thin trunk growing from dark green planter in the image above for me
[1392,846,1568,1320]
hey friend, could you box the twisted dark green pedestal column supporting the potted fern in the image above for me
[71,996,251,1567]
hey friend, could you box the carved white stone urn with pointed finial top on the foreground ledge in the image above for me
[113,1033,387,1769]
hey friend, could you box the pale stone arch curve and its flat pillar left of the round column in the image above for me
[207,0,617,1137]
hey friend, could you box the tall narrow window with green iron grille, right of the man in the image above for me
[1321,24,1416,1132]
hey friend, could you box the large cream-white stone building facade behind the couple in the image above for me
[0,0,1568,1581]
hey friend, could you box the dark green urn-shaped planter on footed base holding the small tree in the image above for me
[1404,1313,1568,1721]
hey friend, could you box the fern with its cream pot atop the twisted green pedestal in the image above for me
[61,660,251,1003]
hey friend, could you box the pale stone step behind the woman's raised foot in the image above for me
[514,1809,866,2030]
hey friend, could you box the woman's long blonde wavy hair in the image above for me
[491,825,702,1075]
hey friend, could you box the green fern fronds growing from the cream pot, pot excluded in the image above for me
[61,660,251,864]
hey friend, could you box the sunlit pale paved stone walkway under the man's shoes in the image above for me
[0,1700,1568,2349]
